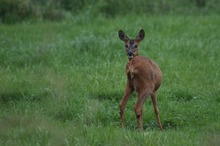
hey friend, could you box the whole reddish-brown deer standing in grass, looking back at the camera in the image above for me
[118,29,163,131]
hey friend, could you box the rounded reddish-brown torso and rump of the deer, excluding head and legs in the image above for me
[126,56,162,92]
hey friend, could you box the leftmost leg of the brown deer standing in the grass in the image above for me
[119,81,134,128]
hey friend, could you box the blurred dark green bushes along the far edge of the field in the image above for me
[0,0,220,23]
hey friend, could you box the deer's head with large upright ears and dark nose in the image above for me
[118,29,145,60]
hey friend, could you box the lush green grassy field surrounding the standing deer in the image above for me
[0,15,220,146]
